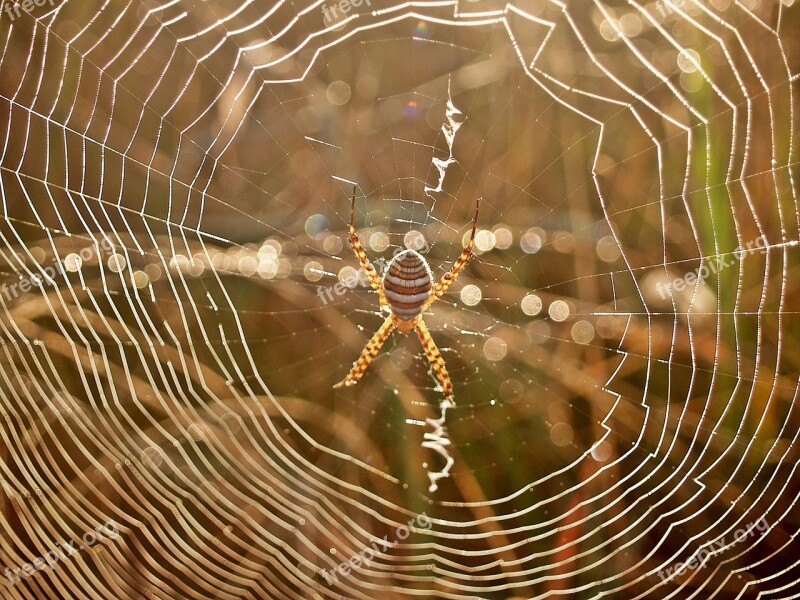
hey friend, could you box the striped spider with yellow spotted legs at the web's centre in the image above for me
[333,188,480,402]
